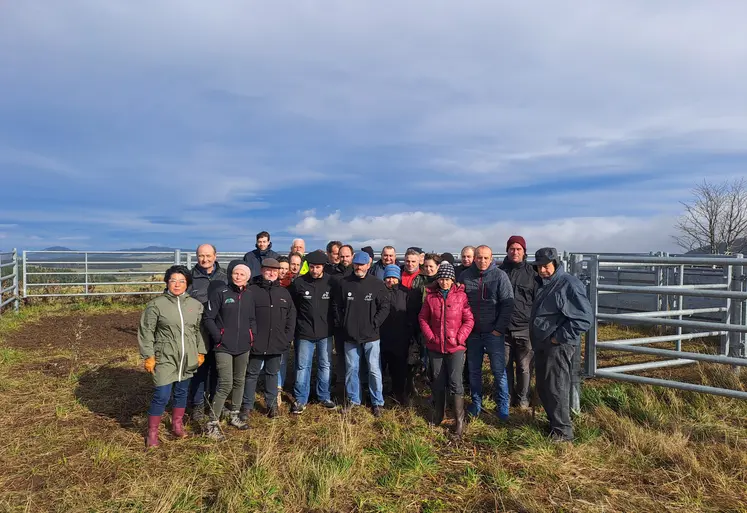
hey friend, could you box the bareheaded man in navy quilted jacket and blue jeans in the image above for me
[459,246,514,420]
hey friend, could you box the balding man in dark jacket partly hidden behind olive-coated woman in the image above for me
[187,244,228,422]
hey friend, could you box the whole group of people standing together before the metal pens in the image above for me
[138,232,592,447]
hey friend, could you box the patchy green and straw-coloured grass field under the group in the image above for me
[0,303,747,512]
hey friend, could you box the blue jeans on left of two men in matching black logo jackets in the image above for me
[293,337,332,404]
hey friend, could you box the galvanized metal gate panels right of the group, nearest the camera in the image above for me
[574,255,747,402]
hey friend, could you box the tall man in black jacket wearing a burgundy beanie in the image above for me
[500,235,541,410]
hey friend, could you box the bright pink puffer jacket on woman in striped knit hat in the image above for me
[418,283,475,354]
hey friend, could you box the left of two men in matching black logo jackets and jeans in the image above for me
[288,250,336,414]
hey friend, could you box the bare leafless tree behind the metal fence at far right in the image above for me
[674,178,747,254]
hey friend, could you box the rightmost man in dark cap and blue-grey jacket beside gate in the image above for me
[529,248,593,442]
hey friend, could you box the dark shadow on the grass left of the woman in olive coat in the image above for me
[75,365,153,428]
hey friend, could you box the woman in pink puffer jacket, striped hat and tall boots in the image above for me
[418,262,475,438]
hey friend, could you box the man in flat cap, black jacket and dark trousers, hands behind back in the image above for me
[241,258,296,421]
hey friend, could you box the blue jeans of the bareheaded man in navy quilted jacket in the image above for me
[467,332,508,419]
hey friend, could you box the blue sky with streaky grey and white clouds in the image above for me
[0,0,747,253]
